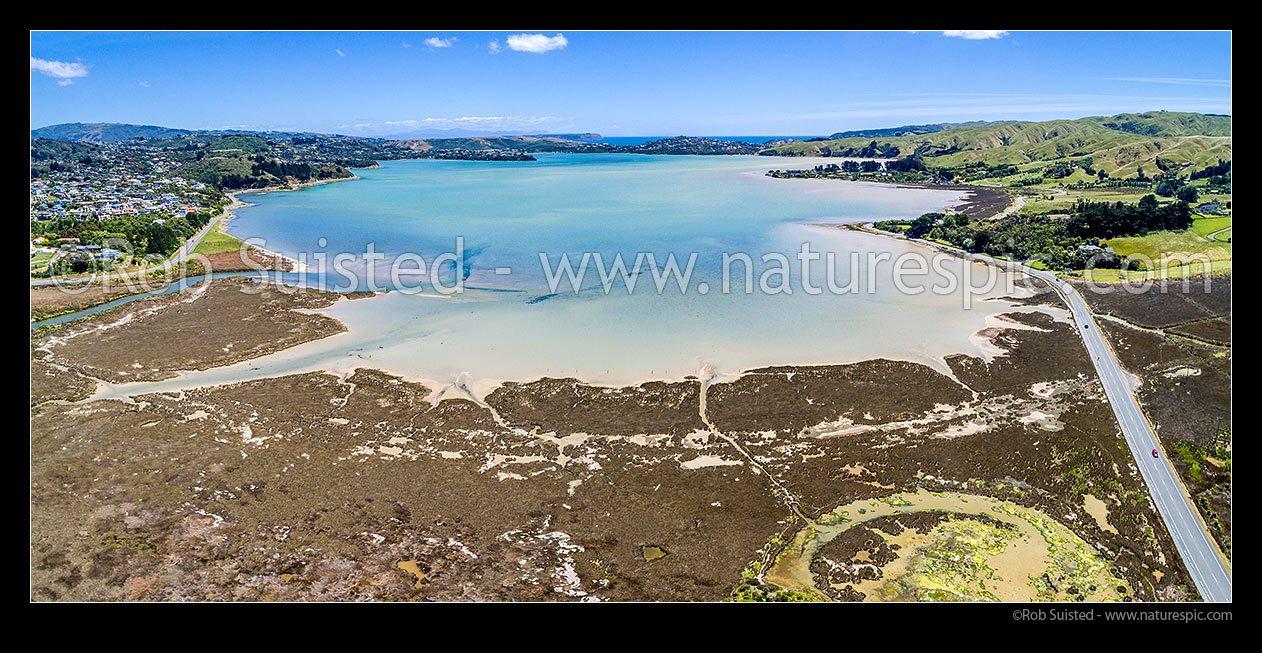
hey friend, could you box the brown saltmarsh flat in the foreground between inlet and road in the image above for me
[32,279,1195,600]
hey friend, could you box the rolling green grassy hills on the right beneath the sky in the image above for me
[760,111,1232,177]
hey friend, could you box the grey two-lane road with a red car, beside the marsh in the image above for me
[1026,268,1232,601]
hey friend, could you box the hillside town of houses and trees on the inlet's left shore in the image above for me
[30,133,411,277]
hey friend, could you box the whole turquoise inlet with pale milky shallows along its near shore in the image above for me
[93,154,1049,395]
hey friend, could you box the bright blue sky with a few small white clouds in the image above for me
[30,30,1232,135]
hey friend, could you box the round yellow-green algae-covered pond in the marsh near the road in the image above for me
[766,489,1128,601]
